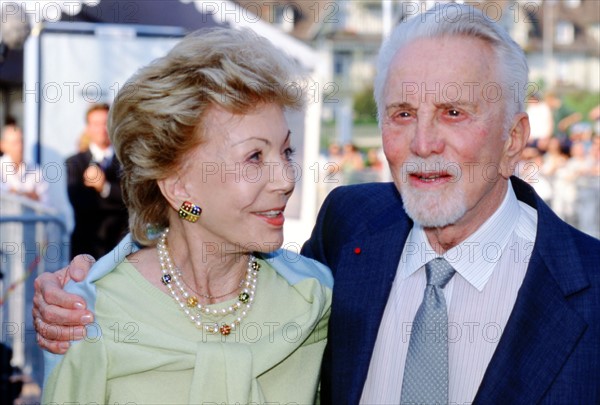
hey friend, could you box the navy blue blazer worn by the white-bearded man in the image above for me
[302,178,600,405]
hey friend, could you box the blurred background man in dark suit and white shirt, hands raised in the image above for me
[66,104,127,259]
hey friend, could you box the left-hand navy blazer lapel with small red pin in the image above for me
[330,218,412,403]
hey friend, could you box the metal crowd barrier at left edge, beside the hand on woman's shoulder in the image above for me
[0,193,69,385]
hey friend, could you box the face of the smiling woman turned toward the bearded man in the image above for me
[173,104,296,253]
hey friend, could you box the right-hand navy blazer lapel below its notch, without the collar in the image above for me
[474,252,587,404]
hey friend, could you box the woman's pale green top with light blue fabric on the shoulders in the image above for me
[42,234,332,405]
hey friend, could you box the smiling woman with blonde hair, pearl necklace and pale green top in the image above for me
[43,29,332,404]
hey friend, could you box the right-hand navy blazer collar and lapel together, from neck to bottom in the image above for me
[474,182,589,404]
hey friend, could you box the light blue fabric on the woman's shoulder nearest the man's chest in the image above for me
[260,249,333,289]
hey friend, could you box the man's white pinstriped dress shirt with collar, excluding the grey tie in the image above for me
[360,182,537,404]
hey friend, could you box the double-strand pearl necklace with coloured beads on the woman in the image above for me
[156,228,260,336]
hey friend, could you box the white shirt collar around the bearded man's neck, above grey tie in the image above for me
[399,181,520,291]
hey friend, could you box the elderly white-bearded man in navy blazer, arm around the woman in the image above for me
[31,4,600,404]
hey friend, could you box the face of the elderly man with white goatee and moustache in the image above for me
[382,36,512,229]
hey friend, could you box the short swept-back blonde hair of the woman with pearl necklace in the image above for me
[108,28,303,246]
